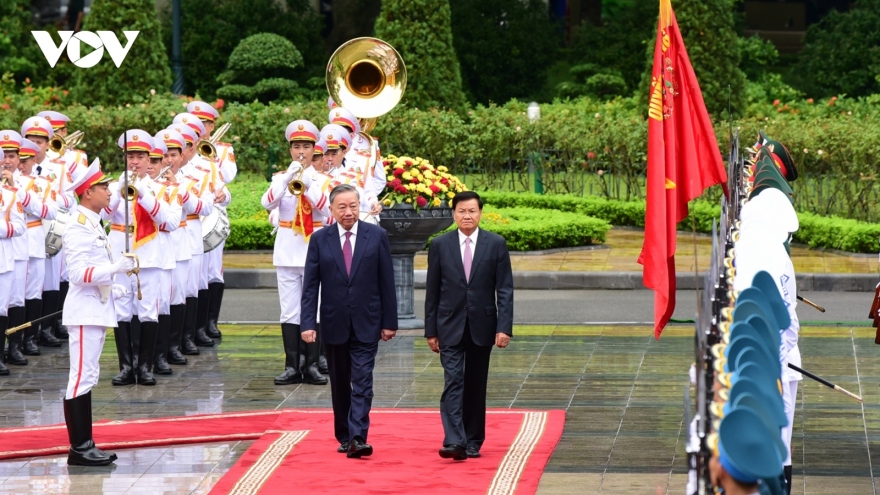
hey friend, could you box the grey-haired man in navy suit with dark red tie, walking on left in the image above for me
[301,184,397,458]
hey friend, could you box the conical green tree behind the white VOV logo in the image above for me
[70,0,171,105]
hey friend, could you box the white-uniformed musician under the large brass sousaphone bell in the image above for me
[327,107,387,215]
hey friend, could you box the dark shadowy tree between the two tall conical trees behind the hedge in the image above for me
[449,0,563,104]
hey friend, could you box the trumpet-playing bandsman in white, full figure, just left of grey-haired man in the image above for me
[262,120,330,385]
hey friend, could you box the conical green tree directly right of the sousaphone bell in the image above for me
[376,0,466,111]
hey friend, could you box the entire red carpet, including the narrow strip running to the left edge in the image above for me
[0,409,565,495]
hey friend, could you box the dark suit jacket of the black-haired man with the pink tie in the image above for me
[425,229,513,345]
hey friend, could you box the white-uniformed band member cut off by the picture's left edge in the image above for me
[0,147,27,375]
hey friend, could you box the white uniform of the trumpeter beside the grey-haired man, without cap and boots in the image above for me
[261,165,330,325]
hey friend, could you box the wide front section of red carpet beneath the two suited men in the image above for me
[211,409,565,495]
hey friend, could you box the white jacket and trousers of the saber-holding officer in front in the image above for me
[62,206,120,399]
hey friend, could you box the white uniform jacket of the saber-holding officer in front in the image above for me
[62,206,116,327]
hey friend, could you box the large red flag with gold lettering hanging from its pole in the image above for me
[639,0,727,339]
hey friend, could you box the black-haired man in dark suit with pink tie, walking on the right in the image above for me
[425,191,513,461]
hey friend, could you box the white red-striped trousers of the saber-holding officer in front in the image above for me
[64,325,107,399]
